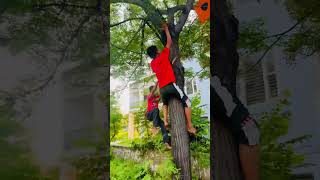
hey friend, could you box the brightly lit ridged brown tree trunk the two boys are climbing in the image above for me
[169,36,192,180]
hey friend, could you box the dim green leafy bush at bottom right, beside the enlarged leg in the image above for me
[259,99,310,180]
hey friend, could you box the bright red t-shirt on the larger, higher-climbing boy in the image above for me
[151,47,176,88]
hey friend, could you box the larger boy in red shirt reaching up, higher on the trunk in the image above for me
[147,23,196,134]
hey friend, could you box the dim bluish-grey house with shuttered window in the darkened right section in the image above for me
[233,0,320,180]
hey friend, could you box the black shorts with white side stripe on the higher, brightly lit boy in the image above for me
[160,83,191,107]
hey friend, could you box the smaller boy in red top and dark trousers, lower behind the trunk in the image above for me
[146,82,171,149]
